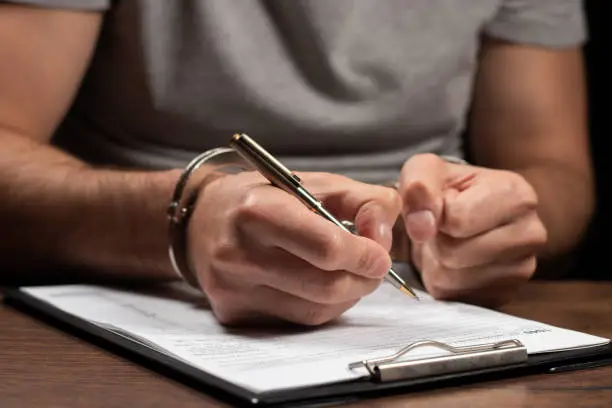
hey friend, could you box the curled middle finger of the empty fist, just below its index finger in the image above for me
[428,211,547,269]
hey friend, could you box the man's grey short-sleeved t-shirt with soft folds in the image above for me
[5,0,586,182]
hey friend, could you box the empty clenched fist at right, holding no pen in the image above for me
[399,154,546,307]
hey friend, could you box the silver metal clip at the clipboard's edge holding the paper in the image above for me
[349,340,528,382]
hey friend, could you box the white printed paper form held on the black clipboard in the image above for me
[23,283,608,392]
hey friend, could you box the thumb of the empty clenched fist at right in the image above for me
[399,154,447,243]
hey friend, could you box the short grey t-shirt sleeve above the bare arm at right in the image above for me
[484,0,588,48]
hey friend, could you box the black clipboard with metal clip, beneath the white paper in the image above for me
[3,288,612,407]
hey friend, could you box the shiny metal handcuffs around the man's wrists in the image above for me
[167,147,468,289]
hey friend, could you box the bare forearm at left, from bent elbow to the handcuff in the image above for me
[0,132,178,282]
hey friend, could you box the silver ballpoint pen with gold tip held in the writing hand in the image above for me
[230,133,419,300]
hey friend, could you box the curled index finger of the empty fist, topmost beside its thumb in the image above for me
[440,171,537,238]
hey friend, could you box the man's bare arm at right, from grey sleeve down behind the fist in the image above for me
[469,39,595,276]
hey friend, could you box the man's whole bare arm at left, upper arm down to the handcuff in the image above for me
[0,5,178,283]
